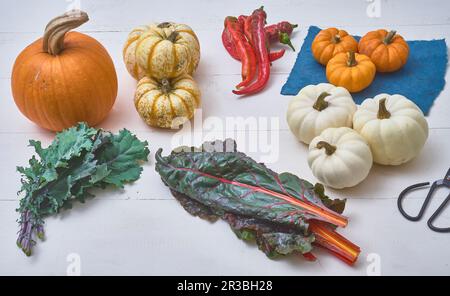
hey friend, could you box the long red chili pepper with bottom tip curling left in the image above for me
[233,7,270,95]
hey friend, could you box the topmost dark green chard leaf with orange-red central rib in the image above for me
[156,141,346,234]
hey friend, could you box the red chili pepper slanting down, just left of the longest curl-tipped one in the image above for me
[225,16,256,88]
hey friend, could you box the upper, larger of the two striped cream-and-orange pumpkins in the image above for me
[123,22,200,79]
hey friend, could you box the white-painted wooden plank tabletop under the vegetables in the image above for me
[0,0,450,275]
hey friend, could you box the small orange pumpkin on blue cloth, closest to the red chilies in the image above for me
[311,28,358,66]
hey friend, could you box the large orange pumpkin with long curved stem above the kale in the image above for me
[11,11,117,131]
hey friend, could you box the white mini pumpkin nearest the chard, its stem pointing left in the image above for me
[308,127,373,189]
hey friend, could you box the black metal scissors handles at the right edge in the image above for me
[397,169,450,233]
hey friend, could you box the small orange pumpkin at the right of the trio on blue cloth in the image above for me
[358,30,409,72]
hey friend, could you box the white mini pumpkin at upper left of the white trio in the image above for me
[286,83,356,144]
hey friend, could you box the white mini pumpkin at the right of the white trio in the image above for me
[353,94,428,165]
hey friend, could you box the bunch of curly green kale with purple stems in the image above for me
[17,123,150,256]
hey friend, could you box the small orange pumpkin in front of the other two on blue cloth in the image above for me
[326,51,376,92]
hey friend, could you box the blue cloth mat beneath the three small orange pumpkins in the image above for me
[281,26,447,114]
